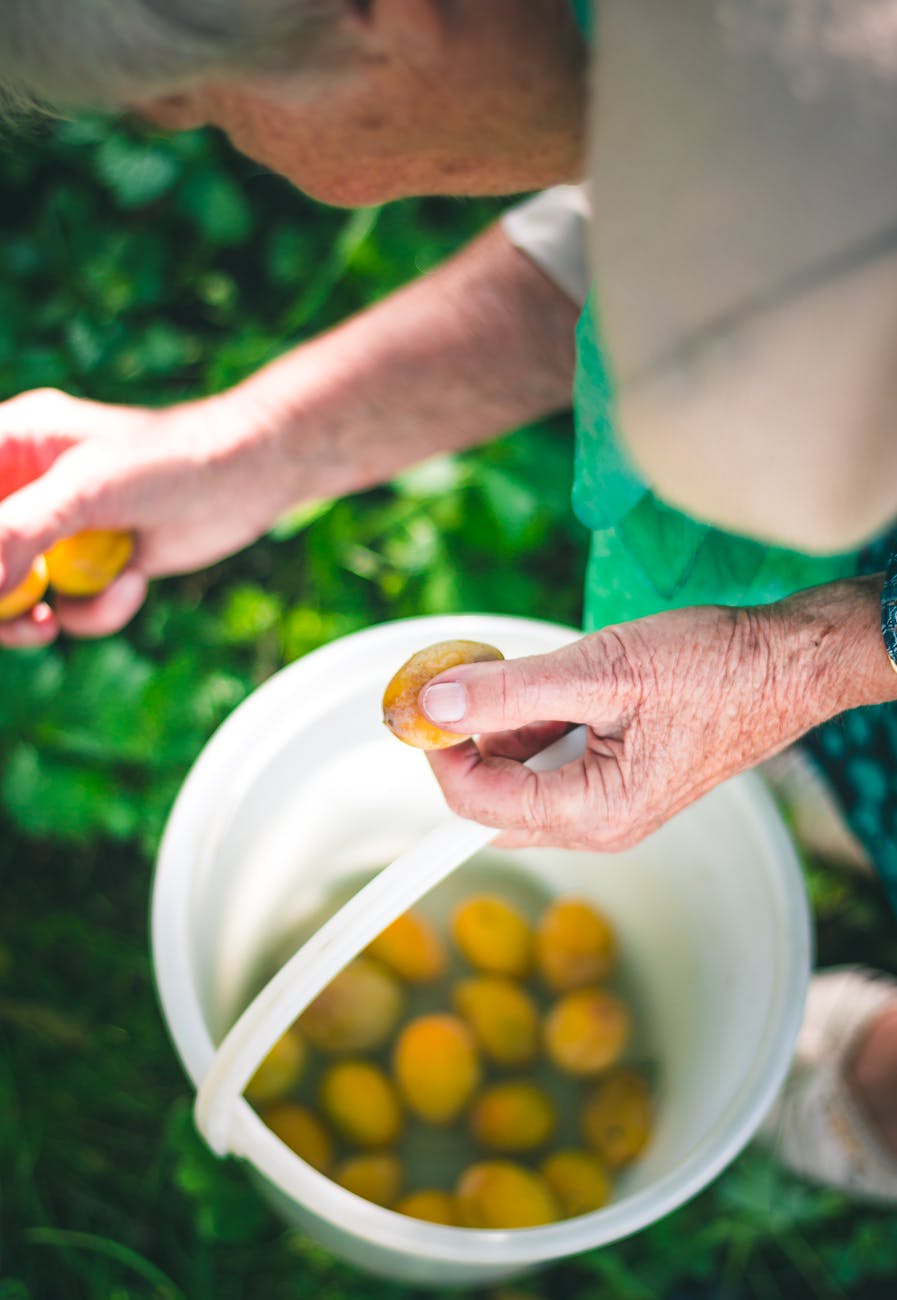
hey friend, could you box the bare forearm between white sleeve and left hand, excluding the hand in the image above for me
[233,226,577,506]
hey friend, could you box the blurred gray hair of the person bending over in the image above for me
[0,0,343,113]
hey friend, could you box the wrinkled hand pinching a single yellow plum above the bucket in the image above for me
[420,607,795,850]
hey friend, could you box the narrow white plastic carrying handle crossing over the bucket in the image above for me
[195,727,585,1156]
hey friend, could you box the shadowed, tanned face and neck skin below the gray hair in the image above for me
[139,0,585,207]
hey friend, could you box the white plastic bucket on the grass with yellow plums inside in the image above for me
[152,616,810,1286]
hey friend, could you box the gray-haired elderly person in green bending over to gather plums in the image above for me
[0,0,897,1199]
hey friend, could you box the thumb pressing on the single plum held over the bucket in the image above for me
[420,637,600,736]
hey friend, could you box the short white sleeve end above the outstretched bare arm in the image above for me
[502,185,592,306]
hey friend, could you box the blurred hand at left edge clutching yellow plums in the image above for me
[0,389,274,646]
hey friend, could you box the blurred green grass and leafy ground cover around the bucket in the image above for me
[0,121,897,1300]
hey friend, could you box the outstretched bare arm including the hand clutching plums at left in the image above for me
[0,228,577,645]
